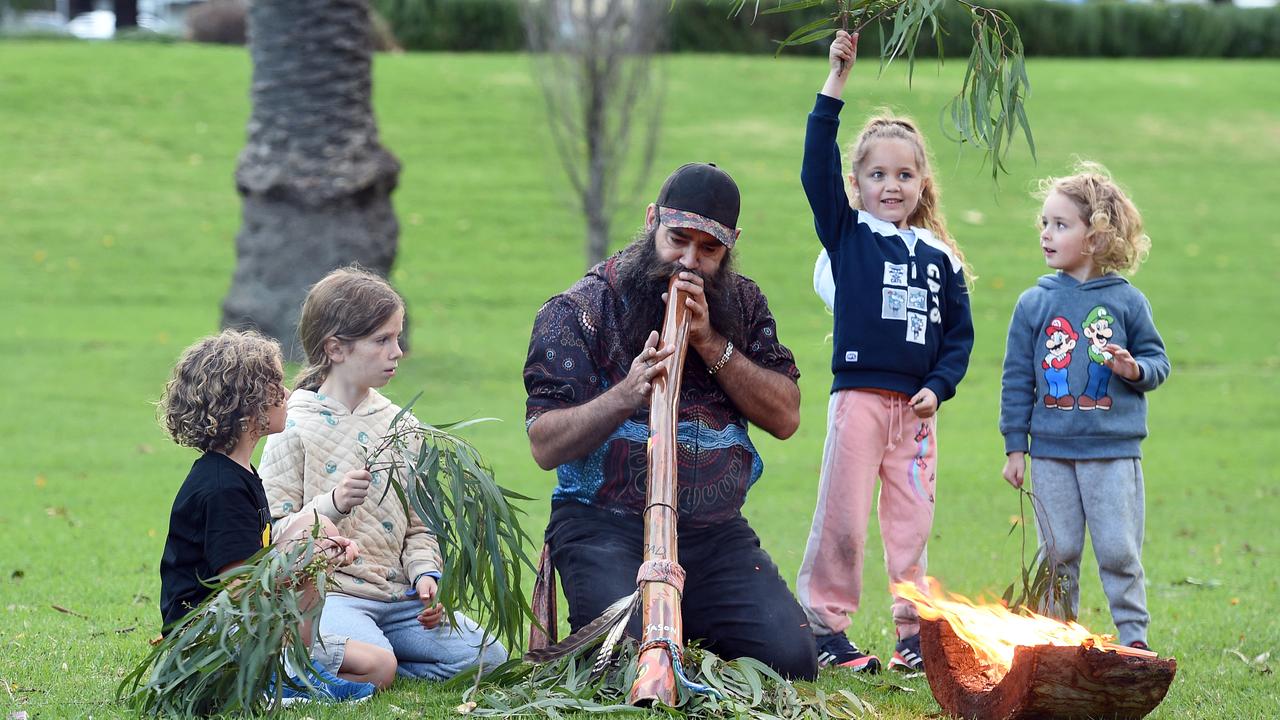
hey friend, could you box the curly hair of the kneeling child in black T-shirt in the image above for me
[157,329,284,452]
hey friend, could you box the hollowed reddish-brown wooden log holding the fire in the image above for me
[920,619,1178,720]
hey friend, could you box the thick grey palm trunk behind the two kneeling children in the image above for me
[223,0,399,360]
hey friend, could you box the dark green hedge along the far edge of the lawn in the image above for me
[374,0,1280,58]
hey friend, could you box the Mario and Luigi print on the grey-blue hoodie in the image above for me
[1041,305,1116,410]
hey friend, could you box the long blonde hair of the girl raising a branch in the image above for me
[849,109,977,288]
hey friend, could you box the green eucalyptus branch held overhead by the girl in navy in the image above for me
[747,0,1036,178]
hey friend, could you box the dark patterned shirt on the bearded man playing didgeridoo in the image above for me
[525,255,800,527]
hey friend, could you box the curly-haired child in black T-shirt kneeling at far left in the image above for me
[160,331,396,701]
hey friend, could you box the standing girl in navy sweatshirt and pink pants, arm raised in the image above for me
[796,31,973,673]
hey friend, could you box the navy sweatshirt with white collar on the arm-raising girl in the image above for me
[800,94,973,402]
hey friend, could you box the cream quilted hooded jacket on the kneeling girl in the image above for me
[259,389,440,601]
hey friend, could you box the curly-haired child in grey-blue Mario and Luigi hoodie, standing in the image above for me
[1000,164,1169,648]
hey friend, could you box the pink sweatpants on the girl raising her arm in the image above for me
[796,389,938,638]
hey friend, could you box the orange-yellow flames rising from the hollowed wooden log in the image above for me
[891,578,1110,682]
